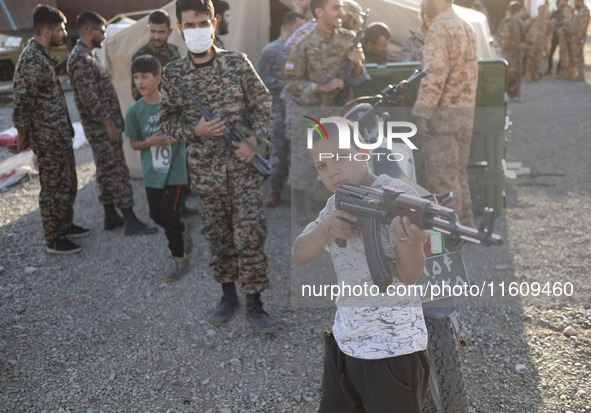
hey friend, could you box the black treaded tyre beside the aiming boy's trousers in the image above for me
[423,313,468,413]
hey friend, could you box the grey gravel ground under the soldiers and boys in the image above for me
[0,43,591,413]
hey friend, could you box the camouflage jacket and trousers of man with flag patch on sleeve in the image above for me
[285,26,355,191]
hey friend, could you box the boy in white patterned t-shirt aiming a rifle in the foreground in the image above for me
[292,117,429,413]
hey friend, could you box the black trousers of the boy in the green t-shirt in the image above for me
[146,185,185,257]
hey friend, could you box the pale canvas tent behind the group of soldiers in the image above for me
[103,0,496,177]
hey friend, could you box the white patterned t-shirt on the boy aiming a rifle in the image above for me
[304,175,427,360]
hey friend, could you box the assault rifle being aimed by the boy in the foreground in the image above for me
[335,184,502,292]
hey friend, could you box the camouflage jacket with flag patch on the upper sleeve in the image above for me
[285,27,355,107]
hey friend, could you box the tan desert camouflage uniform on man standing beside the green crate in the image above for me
[413,8,478,224]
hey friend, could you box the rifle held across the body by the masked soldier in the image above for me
[177,82,273,177]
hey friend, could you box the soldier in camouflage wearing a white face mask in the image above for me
[159,0,277,332]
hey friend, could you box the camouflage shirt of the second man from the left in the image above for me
[68,40,123,131]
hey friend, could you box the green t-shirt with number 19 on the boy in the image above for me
[125,98,188,189]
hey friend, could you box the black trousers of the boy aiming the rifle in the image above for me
[319,332,429,413]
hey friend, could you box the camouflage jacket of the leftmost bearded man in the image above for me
[12,39,74,149]
